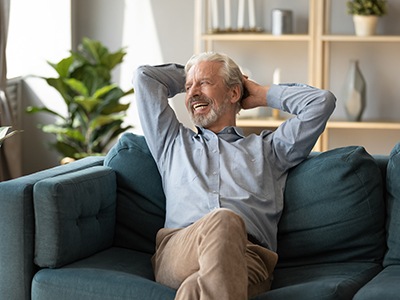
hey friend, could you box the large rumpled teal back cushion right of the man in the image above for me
[278,146,385,267]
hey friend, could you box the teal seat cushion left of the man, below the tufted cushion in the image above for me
[32,247,175,300]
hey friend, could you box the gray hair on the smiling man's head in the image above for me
[185,52,244,112]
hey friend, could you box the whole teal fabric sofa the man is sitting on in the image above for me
[0,133,400,300]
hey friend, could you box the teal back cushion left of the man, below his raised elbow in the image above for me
[104,133,165,253]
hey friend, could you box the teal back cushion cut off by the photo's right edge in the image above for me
[383,143,400,267]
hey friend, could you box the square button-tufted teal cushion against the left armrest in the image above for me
[33,166,117,268]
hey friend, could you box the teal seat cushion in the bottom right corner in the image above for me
[354,265,400,300]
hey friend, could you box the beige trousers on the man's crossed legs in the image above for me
[153,209,278,300]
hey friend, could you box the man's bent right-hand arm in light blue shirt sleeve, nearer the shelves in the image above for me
[267,85,336,169]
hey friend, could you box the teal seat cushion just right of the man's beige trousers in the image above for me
[254,263,382,300]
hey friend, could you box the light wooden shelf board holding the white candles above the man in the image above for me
[201,33,311,42]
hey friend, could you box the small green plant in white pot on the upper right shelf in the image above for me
[347,0,387,36]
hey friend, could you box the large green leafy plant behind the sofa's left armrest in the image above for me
[27,38,133,159]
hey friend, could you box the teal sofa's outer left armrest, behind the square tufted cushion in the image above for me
[0,157,104,299]
